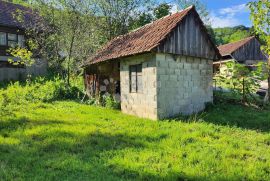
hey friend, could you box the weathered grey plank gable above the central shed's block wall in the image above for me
[157,11,218,60]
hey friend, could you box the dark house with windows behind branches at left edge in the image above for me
[0,0,47,81]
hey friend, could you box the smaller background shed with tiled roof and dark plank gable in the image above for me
[214,36,267,72]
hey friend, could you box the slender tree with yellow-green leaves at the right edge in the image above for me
[248,0,270,102]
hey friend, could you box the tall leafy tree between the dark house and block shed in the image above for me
[13,0,105,85]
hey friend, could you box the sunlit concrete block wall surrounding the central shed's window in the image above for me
[120,54,158,119]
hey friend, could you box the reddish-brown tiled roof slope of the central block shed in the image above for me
[85,6,195,65]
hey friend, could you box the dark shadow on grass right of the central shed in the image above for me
[178,103,270,132]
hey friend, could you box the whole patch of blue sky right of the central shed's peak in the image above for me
[161,0,251,28]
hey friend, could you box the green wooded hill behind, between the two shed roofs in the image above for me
[209,25,253,45]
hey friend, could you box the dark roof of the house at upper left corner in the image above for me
[0,0,41,29]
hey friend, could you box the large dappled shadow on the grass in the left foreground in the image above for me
[0,118,182,180]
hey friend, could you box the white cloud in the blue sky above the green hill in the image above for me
[210,4,248,28]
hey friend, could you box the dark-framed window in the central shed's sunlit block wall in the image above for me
[129,64,142,92]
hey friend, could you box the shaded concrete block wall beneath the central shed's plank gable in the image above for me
[156,54,213,119]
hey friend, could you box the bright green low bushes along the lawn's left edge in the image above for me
[0,77,82,111]
